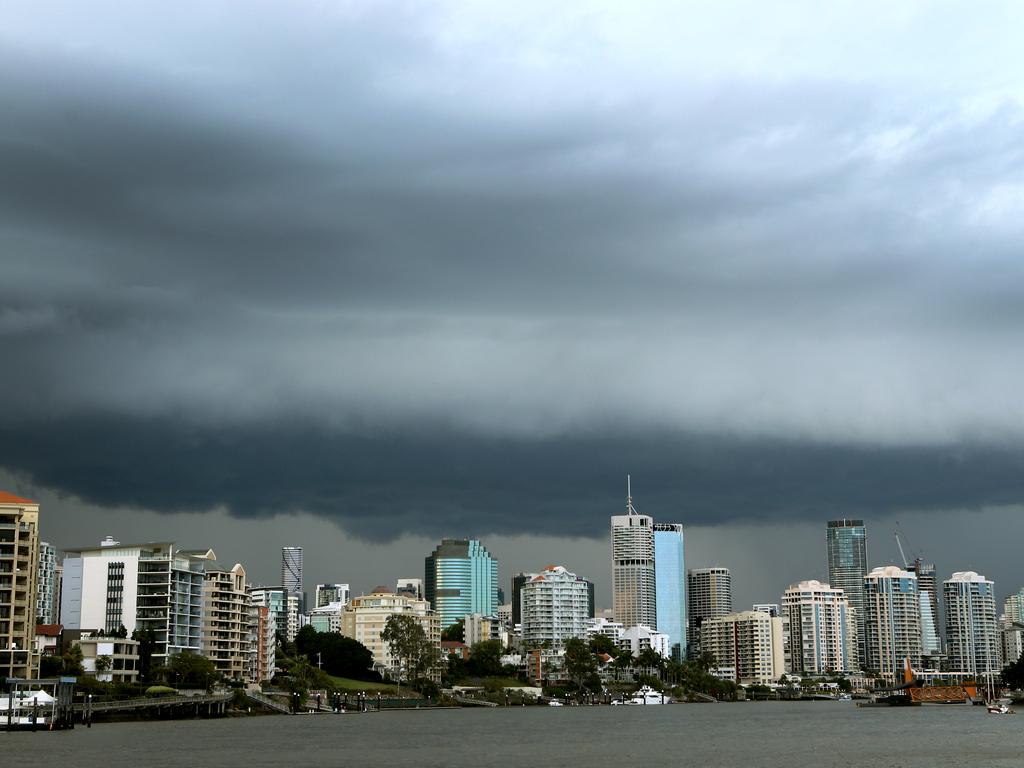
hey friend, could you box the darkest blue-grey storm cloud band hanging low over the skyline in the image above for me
[0,415,1024,540]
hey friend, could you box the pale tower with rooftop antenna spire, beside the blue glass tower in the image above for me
[611,477,657,630]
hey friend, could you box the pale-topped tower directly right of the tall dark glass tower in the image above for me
[864,565,921,683]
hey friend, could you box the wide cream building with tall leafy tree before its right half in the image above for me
[341,587,441,673]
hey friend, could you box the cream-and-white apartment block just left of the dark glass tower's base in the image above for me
[780,580,859,675]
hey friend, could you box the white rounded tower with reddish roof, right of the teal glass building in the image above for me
[522,565,590,648]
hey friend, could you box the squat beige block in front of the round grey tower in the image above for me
[700,610,785,685]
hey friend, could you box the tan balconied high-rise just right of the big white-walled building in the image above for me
[203,559,251,680]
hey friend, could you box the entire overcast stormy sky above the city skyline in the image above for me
[0,0,1024,606]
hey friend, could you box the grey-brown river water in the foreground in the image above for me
[0,701,1024,768]
